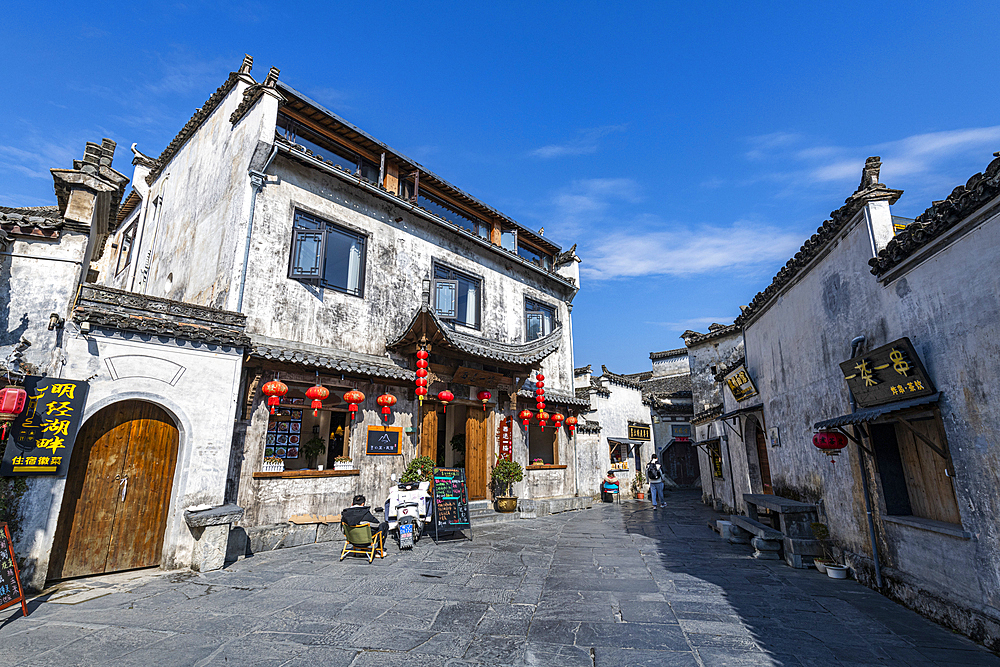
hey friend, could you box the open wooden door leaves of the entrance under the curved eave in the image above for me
[420,402,493,500]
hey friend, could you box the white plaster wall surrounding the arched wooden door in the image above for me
[16,325,242,588]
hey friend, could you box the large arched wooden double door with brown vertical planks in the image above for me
[49,401,178,579]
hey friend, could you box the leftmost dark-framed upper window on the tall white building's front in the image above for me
[288,211,367,296]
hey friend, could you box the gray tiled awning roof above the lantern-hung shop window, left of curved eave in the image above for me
[249,334,416,380]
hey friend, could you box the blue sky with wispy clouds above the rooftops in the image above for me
[0,1,1000,372]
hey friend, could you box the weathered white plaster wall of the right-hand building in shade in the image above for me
[746,202,1000,607]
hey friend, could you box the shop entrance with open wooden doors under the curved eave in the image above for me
[420,401,492,500]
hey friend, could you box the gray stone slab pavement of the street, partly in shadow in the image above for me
[0,492,1000,667]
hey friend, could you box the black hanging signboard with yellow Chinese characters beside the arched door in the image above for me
[0,375,89,477]
